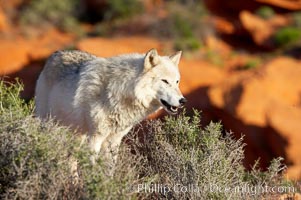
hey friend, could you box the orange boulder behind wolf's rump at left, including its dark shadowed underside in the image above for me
[0,29,74,99]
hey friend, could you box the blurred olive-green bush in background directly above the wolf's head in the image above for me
[150,0,206,52]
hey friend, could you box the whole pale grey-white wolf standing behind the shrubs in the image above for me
[35,49,186,162]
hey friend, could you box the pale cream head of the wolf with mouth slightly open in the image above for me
[139,49,187,114]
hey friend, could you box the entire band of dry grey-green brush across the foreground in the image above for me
[0,82,296,199]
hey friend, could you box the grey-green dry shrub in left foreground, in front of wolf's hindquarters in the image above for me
[0,81,139,199]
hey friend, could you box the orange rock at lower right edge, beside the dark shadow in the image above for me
[266,103,301,180]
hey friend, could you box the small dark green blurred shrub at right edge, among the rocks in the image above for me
[273,27,301,47]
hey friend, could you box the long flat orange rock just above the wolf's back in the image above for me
[76,36,161,57]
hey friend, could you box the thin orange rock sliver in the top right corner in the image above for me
[256,0,301,10]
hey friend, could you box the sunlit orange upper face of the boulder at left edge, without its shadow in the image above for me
[0,29,74,75]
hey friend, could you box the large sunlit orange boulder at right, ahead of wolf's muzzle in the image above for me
[209,57,301,127]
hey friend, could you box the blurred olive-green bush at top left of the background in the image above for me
[20,0,80,32]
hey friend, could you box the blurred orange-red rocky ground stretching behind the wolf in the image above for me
[0,0,301,180]
